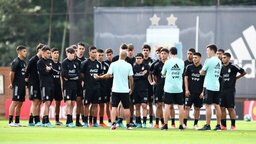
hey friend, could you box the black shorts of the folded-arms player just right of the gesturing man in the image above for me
[132,90,148,104]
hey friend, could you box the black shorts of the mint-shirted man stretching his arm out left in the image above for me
[112,92,130,109]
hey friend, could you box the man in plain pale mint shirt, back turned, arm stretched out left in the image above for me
[99,51,133,130]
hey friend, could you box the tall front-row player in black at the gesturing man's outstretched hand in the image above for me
[81,46,101,127]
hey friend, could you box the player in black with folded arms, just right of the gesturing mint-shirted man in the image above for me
[132,53,149,128]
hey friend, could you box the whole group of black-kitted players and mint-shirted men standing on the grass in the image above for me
[9,43,246,130]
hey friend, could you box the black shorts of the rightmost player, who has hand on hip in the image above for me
[220,89,236,108]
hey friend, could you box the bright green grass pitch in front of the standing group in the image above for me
[0,120,256,144]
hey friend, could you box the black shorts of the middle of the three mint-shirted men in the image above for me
[164,92,183,105]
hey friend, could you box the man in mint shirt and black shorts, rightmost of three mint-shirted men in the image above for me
[199,44,222,130]
